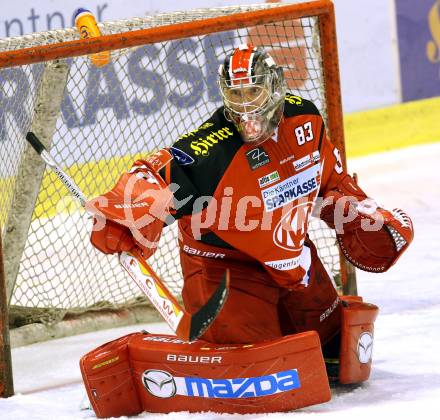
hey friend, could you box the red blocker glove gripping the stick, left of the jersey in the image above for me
[86,160,173,259]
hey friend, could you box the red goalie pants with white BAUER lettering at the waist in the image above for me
[180,235,341,345]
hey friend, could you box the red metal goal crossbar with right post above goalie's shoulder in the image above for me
[0,0,346,188]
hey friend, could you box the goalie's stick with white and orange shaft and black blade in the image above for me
[26,131,229,341]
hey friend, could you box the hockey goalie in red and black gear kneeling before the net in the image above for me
[81,45,413,417]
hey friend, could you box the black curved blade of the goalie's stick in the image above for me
[189,270,230,341]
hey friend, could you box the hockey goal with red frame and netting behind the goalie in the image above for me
[0,0,355,398]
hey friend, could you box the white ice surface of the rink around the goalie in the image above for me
[0,143,440,420]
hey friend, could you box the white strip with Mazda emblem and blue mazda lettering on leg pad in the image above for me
[142,369,301,398]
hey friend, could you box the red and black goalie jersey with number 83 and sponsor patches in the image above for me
[156,94,352,284]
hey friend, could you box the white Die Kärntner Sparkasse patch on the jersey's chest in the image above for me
[261,164,321,212]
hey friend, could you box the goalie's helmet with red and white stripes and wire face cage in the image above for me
[219,44,286,144]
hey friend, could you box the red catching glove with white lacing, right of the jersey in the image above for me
[321,175,414,273]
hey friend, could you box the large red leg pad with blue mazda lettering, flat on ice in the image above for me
[81,331,331,417]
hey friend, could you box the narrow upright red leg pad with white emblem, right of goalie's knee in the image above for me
[339,296,379,384]
